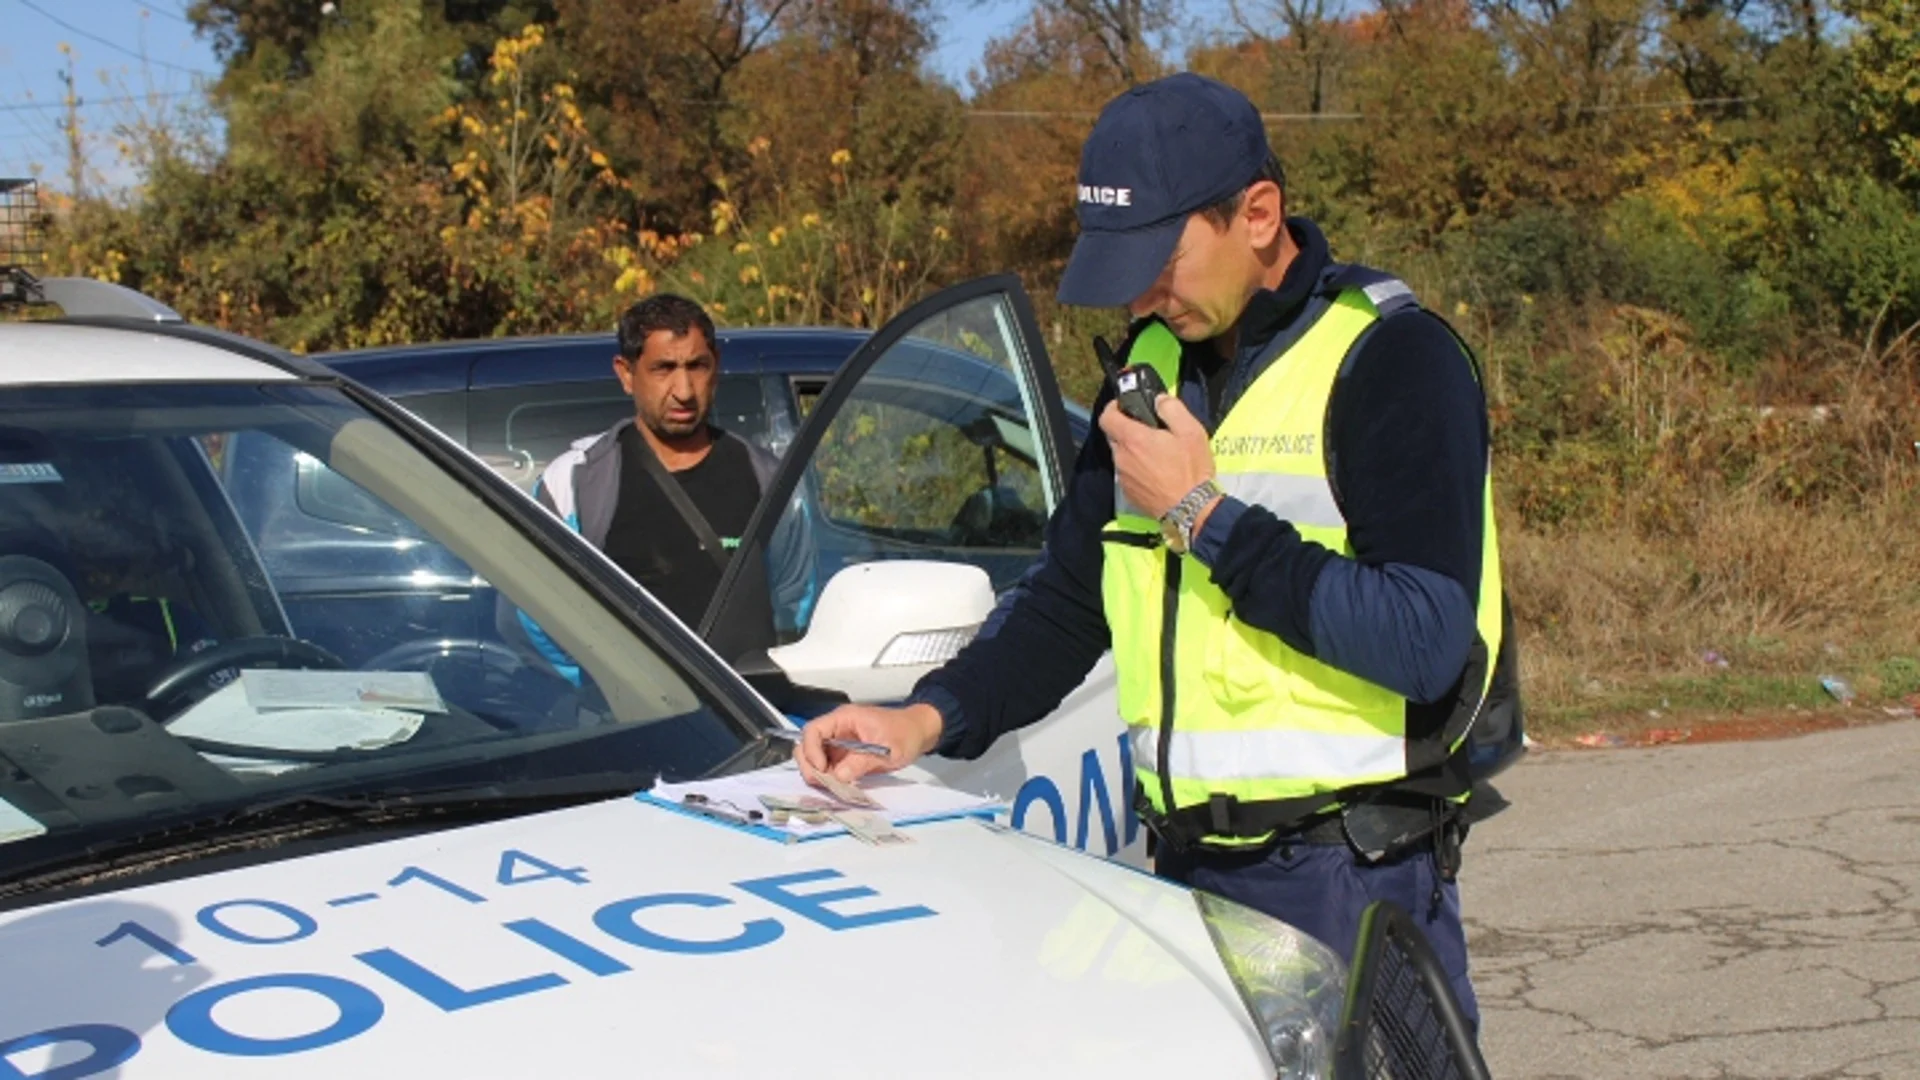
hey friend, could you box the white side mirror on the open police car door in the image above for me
[766,559,993,701]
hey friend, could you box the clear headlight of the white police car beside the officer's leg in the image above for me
[1194,890,1346,1080]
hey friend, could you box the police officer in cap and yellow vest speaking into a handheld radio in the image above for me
[795,75,1505,1022]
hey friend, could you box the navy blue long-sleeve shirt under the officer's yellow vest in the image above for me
[912,217,1488,757]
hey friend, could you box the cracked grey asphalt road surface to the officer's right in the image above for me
[1461,721,1920,1080]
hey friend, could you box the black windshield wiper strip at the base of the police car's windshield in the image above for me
[0,773,653,897]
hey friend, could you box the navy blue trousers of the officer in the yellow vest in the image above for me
[1154,844,1480,1030]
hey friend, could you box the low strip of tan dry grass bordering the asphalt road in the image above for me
[1503,494,1920,728]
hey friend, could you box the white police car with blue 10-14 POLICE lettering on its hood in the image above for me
[0,273,1390,1080]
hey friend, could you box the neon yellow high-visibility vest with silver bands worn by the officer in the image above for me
[1102,288,1501,844]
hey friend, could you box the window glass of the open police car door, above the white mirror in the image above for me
[705,277,1069,668]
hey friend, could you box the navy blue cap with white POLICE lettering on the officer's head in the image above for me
[1060,71,1269,307]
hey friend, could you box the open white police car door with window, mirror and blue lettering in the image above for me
[701,275,1140,855]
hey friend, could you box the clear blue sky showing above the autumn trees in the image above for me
[0,0,1027,188]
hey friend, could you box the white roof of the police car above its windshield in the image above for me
[0,319,303,386]
